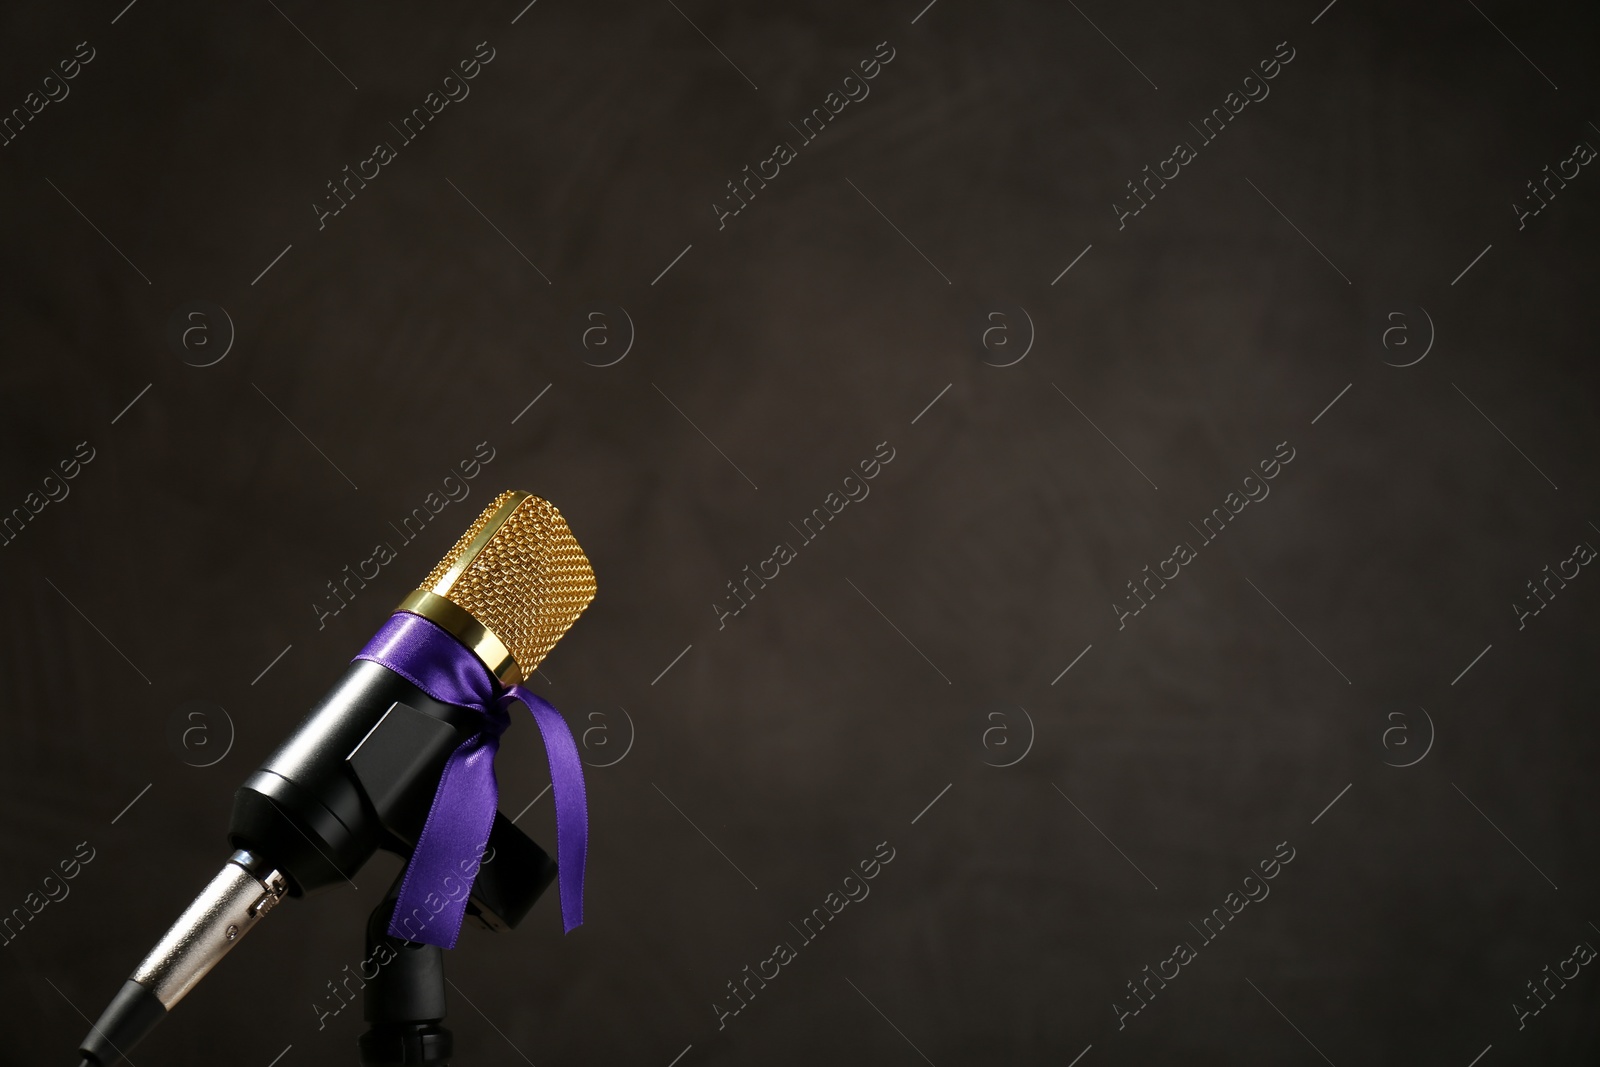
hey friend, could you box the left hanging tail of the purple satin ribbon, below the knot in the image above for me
[389,734,499,949]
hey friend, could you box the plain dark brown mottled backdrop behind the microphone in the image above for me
[0,0,1600,1067]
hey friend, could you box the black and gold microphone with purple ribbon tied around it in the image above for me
[78,491,595,1067]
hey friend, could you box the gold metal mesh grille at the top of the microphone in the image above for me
[419,491,595,678]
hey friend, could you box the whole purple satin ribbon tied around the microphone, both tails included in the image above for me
[355,611,589,949]
